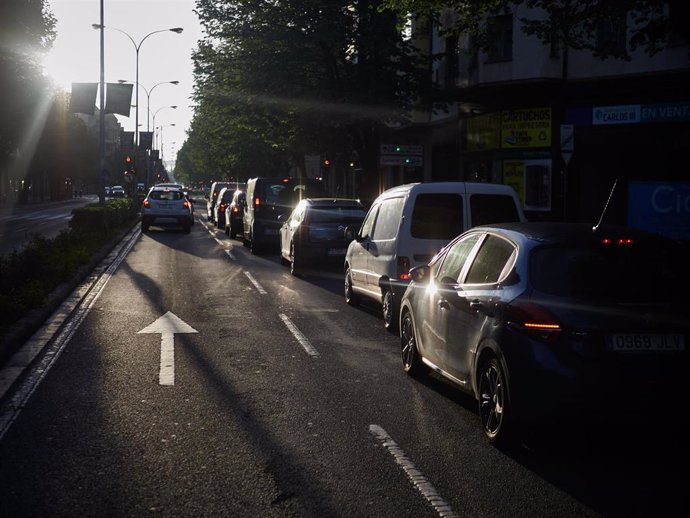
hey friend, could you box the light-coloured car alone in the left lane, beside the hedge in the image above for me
[141,186,194,233]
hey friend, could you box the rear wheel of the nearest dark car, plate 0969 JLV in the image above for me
[477,356,510,444]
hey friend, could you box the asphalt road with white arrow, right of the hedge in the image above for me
[0,211,689,517]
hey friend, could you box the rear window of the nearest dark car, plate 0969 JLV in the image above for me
[530,242,689,303]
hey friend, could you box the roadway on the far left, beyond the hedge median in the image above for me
[0,196,98,255]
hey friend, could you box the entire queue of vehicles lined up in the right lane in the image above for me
[195,179,690,444]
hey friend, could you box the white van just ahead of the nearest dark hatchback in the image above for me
[345,182,525,330]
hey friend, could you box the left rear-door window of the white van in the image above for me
[410,193,465,241]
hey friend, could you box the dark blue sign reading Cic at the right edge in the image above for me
[628,182,690,241]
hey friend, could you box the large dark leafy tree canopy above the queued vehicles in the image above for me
[190,0,430,199]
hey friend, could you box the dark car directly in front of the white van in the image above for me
[279,198,366,275]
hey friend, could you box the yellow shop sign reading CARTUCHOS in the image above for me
[501,108,551,149]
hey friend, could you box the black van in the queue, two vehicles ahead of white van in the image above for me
[242,176,326,254]
